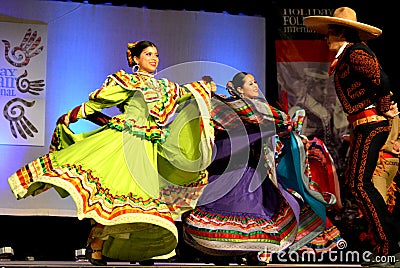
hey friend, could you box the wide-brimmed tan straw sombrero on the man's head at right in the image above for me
[304,7,382,40]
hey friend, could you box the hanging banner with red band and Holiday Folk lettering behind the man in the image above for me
[275,4,348,173]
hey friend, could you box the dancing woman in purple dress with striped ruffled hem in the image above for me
[182,72,340,265]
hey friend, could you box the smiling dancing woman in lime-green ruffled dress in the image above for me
[8,41,214,265]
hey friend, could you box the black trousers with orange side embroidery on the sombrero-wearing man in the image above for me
[347,120,400,256]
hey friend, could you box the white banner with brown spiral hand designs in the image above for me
[0,16,47,146]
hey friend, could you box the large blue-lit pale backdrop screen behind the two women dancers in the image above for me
[0,0,266,216]
